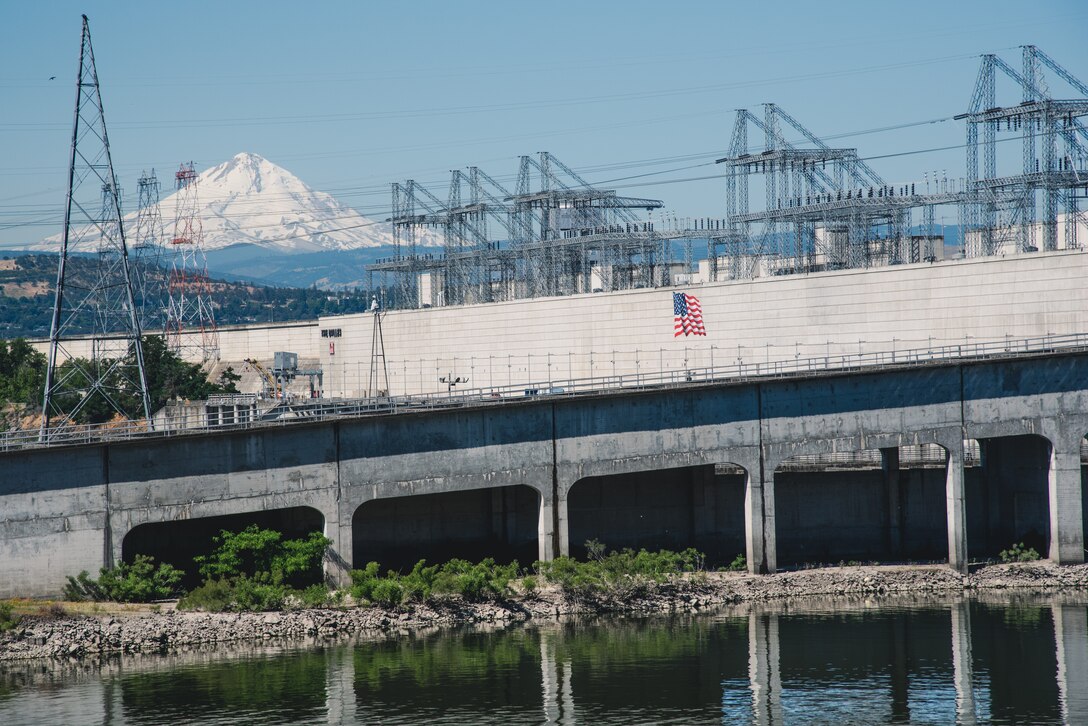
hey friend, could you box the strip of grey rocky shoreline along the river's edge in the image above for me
[0,562,1088,662]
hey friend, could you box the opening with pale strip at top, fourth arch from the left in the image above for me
[775,443,949,567]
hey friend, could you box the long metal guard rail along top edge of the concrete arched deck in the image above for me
[6,333,1088,451]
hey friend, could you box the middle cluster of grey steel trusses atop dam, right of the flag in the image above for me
[710,103,960,279]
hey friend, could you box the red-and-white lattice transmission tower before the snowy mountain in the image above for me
[165,161,219,362]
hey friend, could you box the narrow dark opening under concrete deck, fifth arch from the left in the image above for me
[965,433,1052,561]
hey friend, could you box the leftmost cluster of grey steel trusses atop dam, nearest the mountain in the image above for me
[367,151,725,307]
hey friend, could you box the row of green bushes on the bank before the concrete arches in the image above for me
[65,533,713,612]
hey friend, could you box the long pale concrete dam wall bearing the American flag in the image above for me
[25,249,1088,398]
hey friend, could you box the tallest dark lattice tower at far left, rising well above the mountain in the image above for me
[39,15,151,441]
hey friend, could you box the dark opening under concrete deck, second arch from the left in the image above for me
[351,484,542,571]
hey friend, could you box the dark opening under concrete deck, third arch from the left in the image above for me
[567,464,747,565]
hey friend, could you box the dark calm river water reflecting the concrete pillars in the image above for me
[0,599,1088,726]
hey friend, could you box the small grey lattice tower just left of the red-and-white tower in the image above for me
[131,169,166,330]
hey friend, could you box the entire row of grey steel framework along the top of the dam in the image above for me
[368,46,1088,307]
